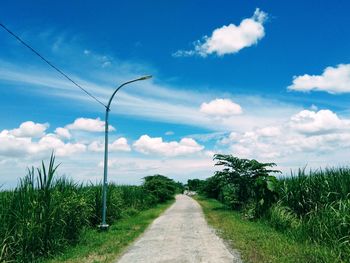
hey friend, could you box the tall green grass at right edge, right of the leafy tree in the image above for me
[269,168,350,260]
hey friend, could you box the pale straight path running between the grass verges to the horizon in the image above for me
[117,195,241,263]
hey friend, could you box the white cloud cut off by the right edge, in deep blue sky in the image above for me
[288,64,350,94]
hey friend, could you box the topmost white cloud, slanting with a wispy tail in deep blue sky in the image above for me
[173,8,268,57]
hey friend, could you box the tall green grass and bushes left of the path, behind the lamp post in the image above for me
[0,156,177,262]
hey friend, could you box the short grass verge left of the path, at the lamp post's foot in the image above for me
[43,201,174,263]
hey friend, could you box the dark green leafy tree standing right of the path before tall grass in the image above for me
[214,154,280,216]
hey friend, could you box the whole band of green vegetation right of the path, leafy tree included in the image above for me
[194,155,350,262]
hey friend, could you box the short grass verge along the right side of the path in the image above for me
[196,197,342,263]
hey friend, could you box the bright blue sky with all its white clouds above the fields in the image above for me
[0,0,350,188]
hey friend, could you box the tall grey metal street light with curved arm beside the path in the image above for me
[99,75,152,230]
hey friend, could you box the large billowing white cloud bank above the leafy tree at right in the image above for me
[220,110,350,161]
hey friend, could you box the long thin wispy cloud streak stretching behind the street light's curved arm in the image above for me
[0,57,300,131]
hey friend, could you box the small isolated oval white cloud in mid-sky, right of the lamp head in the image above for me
[200,99,243,117]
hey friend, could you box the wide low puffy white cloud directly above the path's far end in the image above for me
[133,135,204,157]
